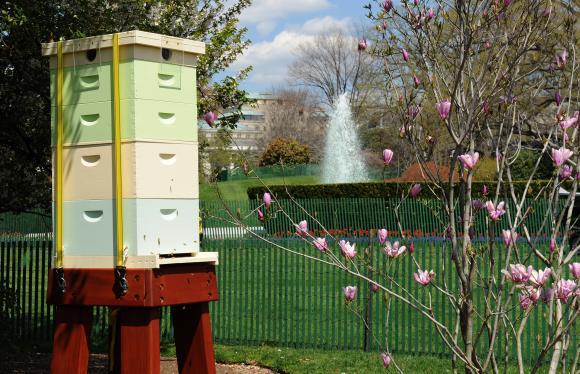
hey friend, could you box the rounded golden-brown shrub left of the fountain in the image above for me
[260,138,312,166]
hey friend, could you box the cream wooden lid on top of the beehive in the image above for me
[42,30,205,56]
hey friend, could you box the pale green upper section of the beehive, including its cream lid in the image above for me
[42,31,205,145]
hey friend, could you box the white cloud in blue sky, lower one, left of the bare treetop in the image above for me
[232,16,353,90]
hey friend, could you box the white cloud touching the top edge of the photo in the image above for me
[240,0,331,23]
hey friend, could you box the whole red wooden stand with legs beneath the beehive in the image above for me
[47,263,218,374]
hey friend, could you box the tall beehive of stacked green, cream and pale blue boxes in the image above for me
[43,31,216,268]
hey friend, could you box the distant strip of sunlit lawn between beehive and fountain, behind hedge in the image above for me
[199,176,320,201]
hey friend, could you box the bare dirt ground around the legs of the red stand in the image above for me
[0,353,274,374]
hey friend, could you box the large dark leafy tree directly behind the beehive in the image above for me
[0,0,250,211]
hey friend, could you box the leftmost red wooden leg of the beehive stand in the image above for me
[50,305,93,374]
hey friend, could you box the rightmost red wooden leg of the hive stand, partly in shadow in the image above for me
[171,303,215,374]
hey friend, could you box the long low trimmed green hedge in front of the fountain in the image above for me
[248,180,568,199]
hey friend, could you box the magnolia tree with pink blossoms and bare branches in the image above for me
[206,0,580,373]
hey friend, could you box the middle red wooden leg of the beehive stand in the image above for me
[116,308,160,374]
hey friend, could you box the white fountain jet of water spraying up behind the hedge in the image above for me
[322,93,368,183]
